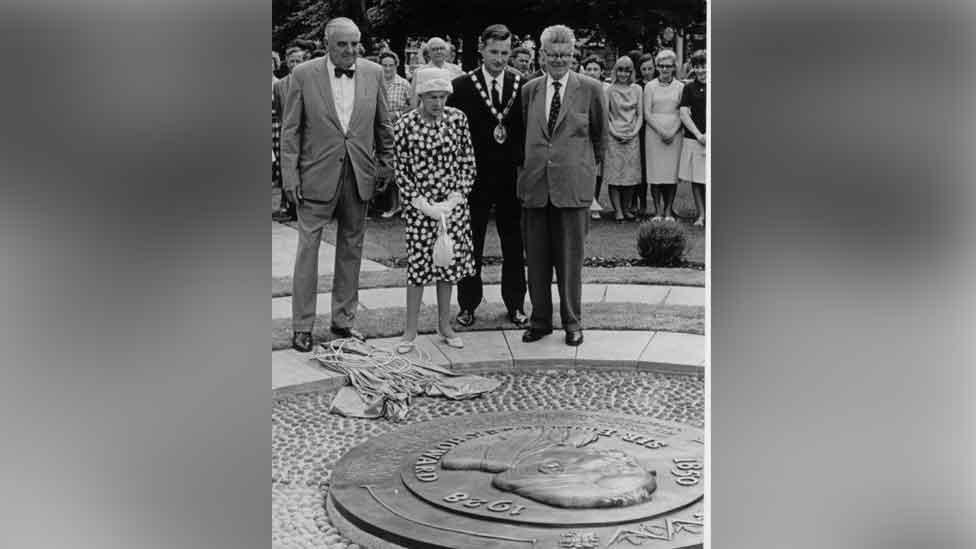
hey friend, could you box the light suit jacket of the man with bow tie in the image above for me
[281,57,393,202]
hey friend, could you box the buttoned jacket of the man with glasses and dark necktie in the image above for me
[517,71,607,208]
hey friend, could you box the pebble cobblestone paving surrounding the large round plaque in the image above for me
[271,370,705,549]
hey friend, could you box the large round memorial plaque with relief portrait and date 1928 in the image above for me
[328,412,705,549]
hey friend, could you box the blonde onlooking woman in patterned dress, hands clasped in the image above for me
[603,56,644,223]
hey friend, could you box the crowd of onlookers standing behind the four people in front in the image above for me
[272,27,707,226]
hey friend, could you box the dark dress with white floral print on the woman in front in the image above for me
[393,107,475,286]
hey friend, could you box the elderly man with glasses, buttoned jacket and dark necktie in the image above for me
[517,25,607,346]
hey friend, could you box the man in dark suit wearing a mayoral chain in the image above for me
[447,25,528,327]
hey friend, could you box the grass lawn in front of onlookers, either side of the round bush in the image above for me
[271,184,706,266]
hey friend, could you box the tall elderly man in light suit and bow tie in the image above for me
[281,17,393,352]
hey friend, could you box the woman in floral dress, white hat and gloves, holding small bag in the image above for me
[393,68,475,353]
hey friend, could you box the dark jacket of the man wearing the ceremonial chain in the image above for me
[447,66,525,197]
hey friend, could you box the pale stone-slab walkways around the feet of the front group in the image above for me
[271,222,706,393]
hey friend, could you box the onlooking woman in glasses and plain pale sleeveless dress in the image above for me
[641,50,684,222]
